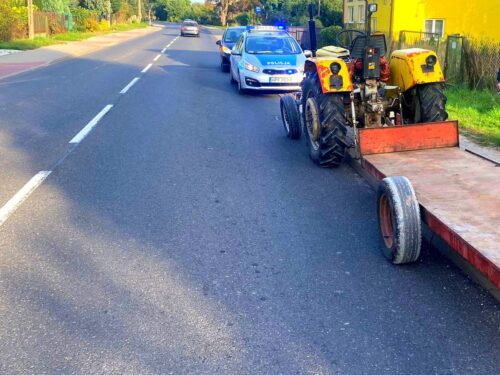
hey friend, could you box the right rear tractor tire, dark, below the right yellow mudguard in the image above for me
[415,83,448,122]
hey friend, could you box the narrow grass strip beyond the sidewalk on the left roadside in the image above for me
[0,22,149,51]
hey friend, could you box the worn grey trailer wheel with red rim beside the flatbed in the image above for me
[377,176,422,264]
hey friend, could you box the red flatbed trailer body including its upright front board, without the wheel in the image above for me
[351,121,500,292]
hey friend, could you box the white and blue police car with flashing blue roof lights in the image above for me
[229,26,306,93]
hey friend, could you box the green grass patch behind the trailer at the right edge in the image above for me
[446,87,500,147]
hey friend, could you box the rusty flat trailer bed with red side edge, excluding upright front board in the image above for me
[361,147,500,288]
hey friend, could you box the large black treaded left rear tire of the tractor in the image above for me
[302,73,350,167]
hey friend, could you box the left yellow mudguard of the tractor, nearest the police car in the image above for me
[304,57,352,94]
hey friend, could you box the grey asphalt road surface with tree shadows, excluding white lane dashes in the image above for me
[0,26,500,375]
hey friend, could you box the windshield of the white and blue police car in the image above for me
[245,36,302,55]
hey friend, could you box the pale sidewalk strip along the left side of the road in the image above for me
[0,25,162,81]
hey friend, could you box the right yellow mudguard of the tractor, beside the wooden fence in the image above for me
[390,48,445,92]
